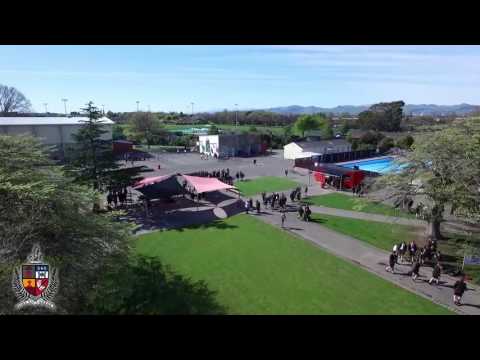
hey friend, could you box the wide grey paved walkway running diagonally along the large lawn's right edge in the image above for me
[248,200,480,315]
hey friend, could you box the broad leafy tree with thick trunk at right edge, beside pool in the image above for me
[377,121,480,239]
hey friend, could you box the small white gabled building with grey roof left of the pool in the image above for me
[283,139,352,160]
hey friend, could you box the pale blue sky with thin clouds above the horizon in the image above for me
[0,45,480,112]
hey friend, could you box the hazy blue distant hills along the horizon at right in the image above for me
[263,104,480,115]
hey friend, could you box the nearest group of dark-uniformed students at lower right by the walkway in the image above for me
[385,239,467,306]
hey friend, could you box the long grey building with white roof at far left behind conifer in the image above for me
[0,117,114,147]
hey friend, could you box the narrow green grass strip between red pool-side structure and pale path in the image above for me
[304,193,415,219]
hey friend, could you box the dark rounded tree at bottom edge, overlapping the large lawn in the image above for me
[89,256,226,315]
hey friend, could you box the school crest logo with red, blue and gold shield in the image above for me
[12,244,59,310]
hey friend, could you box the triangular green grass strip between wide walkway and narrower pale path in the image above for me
[312,213,416,251]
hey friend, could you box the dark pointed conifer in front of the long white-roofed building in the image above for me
[66,101,119,190]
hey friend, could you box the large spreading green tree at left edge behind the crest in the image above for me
[0,135,131,314]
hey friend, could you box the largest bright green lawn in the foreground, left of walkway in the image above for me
[136,215,450,314]
